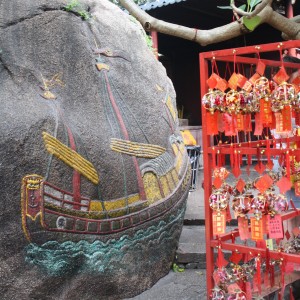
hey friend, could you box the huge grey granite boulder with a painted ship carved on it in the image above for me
[0,0,190,300]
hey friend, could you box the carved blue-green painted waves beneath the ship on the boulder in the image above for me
[25,206,185,276]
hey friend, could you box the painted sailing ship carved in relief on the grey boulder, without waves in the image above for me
[21,49,191,242]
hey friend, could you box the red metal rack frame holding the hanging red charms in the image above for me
[200,41,300,299]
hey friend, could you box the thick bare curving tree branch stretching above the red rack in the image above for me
[119,0,300,46]
